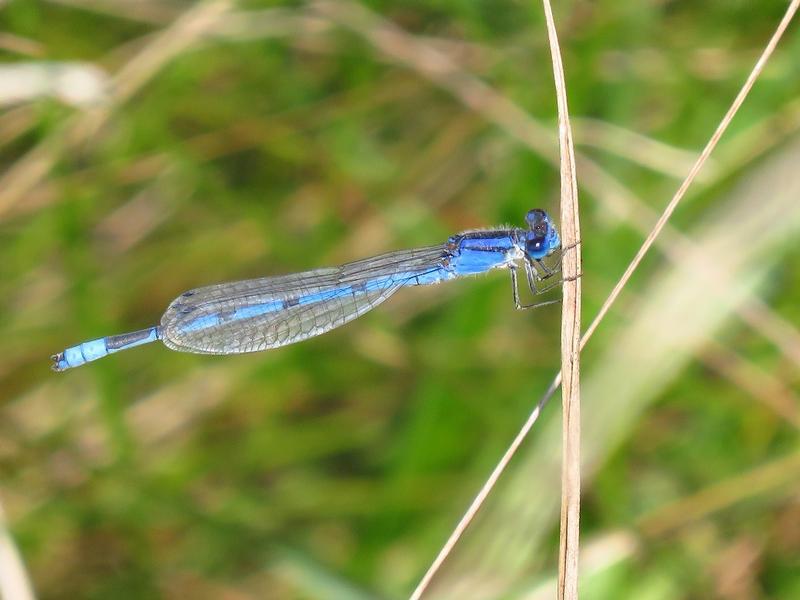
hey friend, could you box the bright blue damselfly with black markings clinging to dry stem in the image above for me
[52,209,561,371]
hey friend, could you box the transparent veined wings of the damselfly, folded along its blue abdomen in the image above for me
[161,245,447,354]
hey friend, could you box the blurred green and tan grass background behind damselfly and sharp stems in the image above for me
[0,0,800,599]
